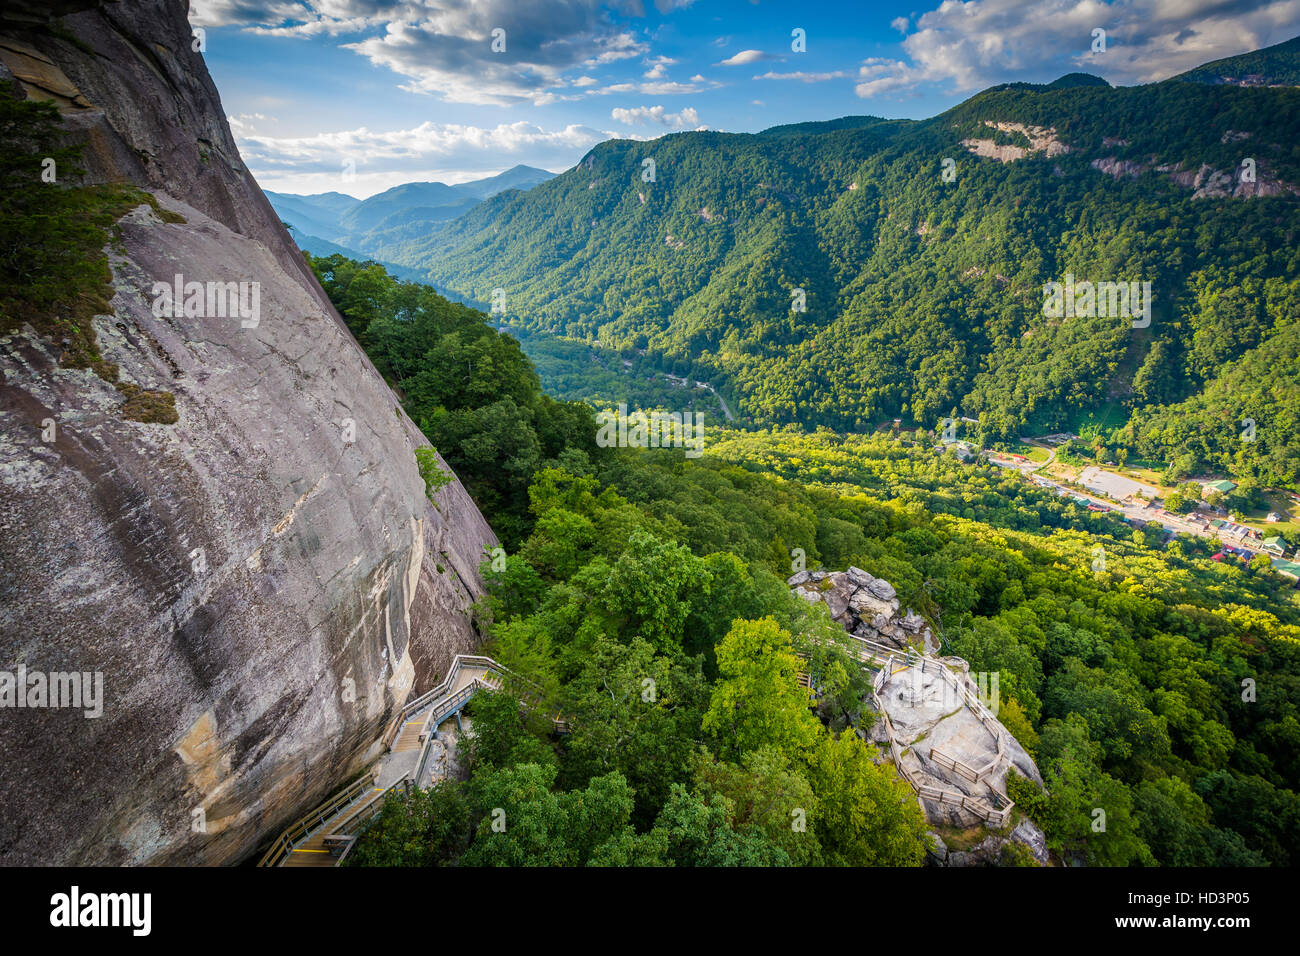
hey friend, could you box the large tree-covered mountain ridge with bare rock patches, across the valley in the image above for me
[405,42,1300,484]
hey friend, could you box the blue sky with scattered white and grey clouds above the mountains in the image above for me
[190,0,1300,196]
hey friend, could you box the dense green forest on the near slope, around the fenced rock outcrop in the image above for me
[311,256,1300,866]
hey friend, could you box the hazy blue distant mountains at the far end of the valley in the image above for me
[267,165,555,277]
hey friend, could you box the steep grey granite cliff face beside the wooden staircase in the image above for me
[0,0,497,864]
